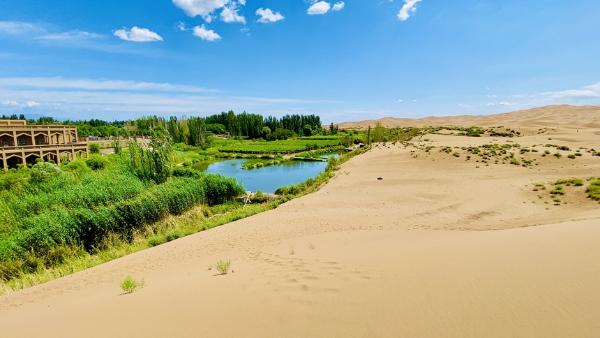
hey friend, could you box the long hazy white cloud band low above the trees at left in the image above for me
[0,77,328,119]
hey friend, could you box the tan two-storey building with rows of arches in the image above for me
[0,120,88,169]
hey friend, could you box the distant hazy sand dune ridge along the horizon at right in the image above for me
[339,105,600,129]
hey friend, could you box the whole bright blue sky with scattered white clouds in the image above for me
[0,0,600,122]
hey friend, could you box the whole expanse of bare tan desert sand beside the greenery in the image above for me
[0,107,600,337]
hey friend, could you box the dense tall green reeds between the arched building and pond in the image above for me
[0,144,243,281]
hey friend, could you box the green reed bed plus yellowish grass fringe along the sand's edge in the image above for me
[0,136,376,294]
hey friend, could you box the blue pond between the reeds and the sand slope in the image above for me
[206,160,327,193]
